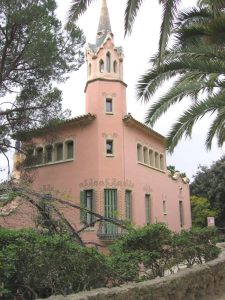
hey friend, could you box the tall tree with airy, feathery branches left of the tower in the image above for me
[0,0,85,166]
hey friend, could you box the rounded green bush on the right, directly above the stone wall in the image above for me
[109,223,219,282]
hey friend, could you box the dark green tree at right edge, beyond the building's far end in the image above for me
[190,156,225,226]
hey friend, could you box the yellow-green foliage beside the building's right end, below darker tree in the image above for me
[191,196,219,227]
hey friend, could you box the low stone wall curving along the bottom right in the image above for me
[44,243,225,300]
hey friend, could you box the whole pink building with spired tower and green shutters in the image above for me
[9,0,191,243]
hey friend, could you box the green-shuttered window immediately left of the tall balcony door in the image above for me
[80,190,95,226]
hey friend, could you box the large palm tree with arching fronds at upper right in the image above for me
[137,0,225,152]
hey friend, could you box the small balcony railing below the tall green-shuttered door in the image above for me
[97,222,126,241]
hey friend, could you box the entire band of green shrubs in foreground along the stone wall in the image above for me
[0,223,219,300]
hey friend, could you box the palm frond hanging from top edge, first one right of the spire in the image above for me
[124,0,143,36]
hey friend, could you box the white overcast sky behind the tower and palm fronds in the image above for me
[0,0,225,179]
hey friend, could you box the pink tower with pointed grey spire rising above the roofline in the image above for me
[85,0,126,117]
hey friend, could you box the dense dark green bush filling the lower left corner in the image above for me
[0,229,108,299]
